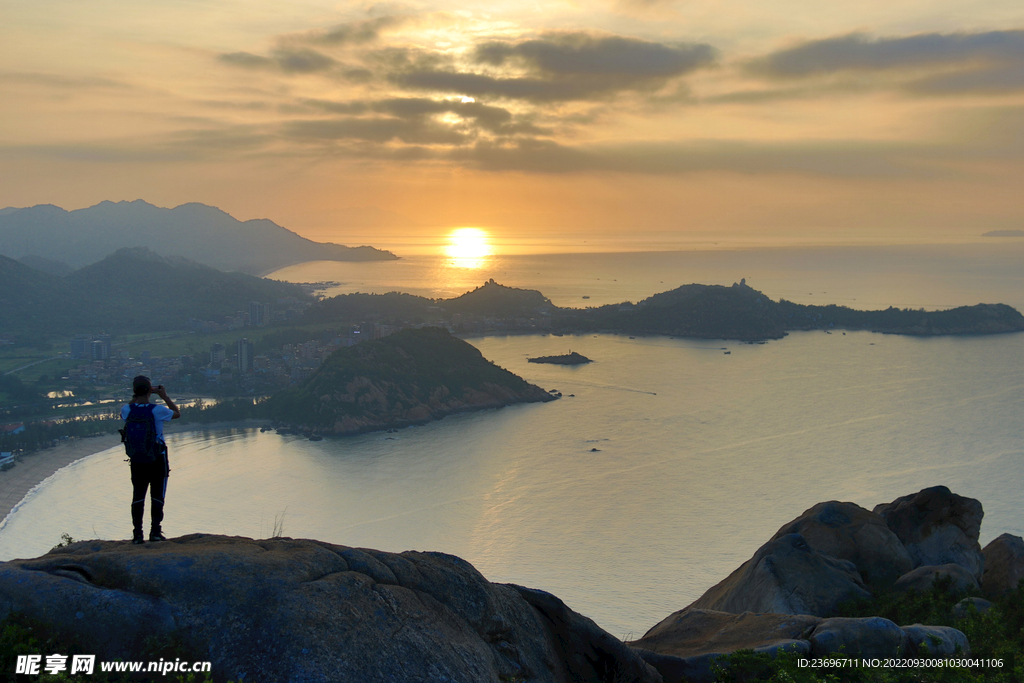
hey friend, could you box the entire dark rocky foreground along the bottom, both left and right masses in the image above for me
[0,486,1024,683]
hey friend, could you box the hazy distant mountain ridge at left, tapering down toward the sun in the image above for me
[0,200,397,274]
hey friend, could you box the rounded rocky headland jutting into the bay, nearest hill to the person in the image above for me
[257,328,555,435]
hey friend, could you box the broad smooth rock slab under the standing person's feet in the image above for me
[0,533,660,683]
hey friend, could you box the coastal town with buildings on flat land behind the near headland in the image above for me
[0,283,551,467]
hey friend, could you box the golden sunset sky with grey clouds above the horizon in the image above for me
[0,0,1024,243]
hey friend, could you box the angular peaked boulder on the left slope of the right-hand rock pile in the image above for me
[688,533,870,616]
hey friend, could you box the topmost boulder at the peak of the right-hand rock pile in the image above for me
[873,486,985,581]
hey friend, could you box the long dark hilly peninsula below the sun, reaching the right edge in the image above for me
[305,280,1024,341]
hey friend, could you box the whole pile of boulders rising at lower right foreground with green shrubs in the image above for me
[630,486,987,683]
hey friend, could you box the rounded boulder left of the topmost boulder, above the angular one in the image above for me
[772,501,913,588]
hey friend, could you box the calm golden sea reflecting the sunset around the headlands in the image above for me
[0,241,1024,639]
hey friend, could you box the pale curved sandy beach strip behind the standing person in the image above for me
[0,420,266,525]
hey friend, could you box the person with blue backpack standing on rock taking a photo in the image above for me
[120,375,181,544]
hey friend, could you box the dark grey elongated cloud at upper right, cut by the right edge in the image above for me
[748,30,1024,78]
